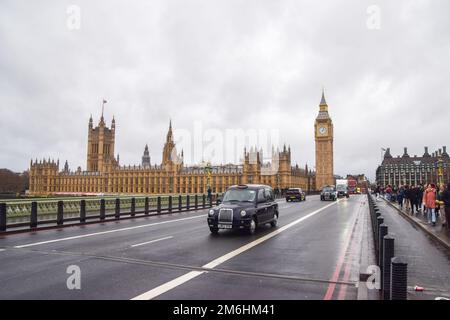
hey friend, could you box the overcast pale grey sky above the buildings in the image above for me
[0,0,450,178]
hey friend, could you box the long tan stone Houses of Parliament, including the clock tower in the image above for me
[29,92,334,195]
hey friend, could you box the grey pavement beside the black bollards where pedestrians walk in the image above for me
[377,200,450,300]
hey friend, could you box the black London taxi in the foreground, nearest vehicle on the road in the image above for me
[208,184,278,234]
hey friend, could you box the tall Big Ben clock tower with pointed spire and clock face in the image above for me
[314,91,335,190]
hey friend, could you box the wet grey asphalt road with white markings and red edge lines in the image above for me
[0,196,367,299]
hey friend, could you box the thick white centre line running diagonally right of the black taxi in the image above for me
[131,200,341,300]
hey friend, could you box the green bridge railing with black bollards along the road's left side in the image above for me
[0,193,220,234]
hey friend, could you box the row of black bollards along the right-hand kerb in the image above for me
[367,192,408,300]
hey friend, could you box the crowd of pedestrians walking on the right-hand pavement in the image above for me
[375,183,450,230]
